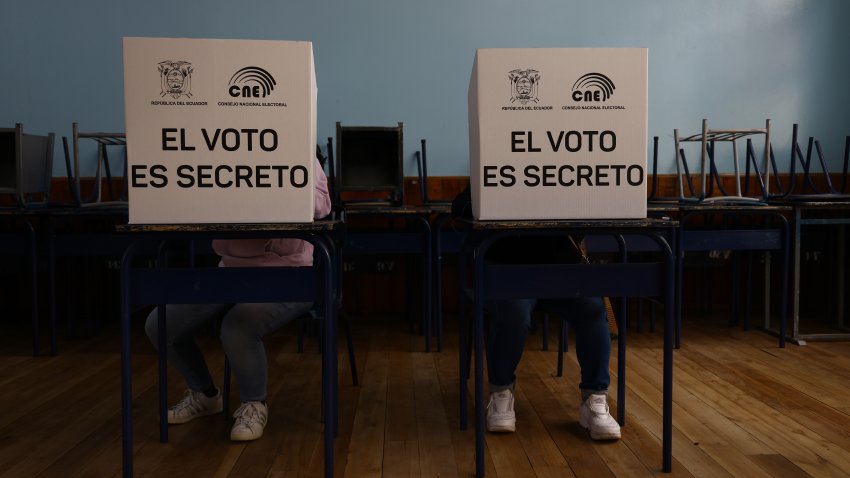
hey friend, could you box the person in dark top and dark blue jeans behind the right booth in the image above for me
[452,187,620,440]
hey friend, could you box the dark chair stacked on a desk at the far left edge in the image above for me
[0,123,55,207]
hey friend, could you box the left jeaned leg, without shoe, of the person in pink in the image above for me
[145,304,230,392]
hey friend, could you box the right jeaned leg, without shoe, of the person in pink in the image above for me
[221,302,312,402]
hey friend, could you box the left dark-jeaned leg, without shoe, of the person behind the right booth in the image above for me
[485,299,536,393]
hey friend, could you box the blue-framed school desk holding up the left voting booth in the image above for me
[119,221,339,477]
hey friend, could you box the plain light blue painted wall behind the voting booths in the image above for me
[0,0,850,176]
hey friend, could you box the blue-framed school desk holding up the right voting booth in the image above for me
[459,219,677,477]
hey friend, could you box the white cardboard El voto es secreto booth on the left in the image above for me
[124,38,316,224]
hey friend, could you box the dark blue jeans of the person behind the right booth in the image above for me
[486,297,611,392]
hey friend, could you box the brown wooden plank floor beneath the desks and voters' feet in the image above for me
[0,312,850,478]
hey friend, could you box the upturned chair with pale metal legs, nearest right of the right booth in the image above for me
[673,119,771,203]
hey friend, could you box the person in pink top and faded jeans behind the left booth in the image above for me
[145,154,331,441]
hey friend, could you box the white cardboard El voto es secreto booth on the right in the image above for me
[469,48,647,220]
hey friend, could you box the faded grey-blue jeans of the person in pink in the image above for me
[145,302,312,402]
